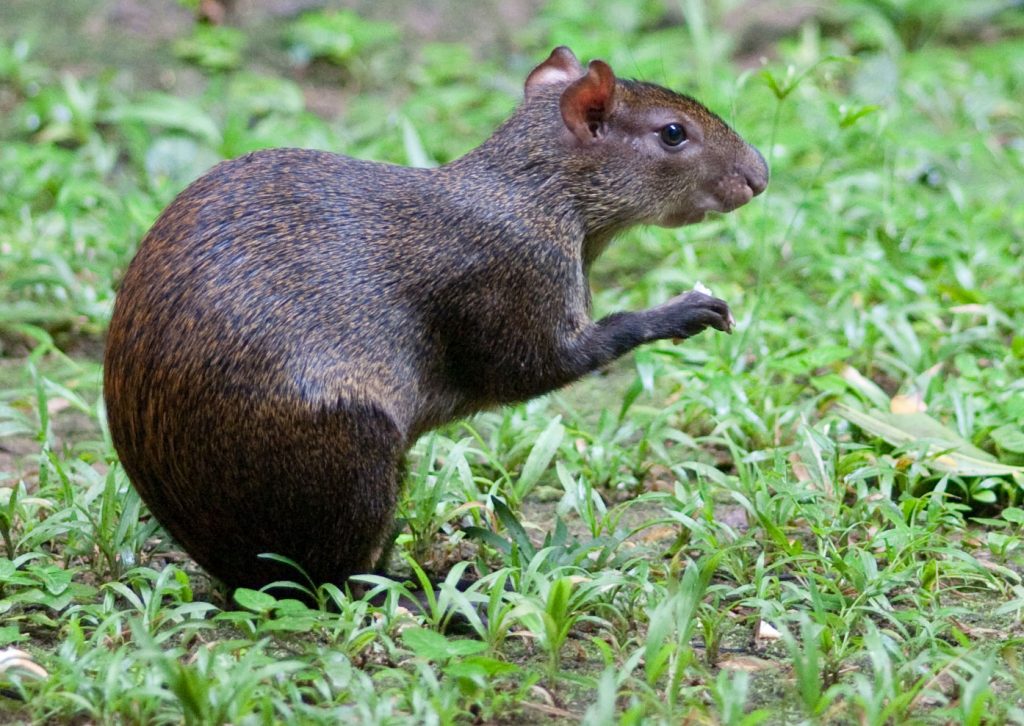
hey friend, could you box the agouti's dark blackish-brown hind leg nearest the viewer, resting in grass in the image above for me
[190,401,404,594]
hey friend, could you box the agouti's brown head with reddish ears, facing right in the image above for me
[524,47,768,230]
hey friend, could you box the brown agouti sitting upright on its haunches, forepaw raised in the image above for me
[103,47,768,587]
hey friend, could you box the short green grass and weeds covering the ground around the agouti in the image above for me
[0,0,1024,724]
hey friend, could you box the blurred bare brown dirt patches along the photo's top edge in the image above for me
[0,0,824,101]
